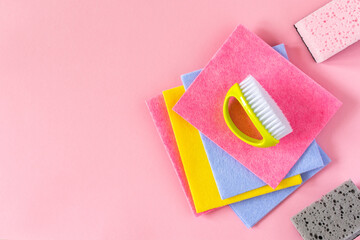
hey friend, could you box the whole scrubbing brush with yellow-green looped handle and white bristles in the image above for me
[223,75,292,148]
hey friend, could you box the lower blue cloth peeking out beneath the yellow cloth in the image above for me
[230,146,331,228]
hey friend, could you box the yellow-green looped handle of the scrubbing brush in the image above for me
[223,83,279,148]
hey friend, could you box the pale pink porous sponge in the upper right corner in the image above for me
[295,0,360,63]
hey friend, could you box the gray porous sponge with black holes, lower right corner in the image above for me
[291,180,360,240]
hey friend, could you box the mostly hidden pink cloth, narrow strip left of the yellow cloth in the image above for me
[146,94,206,216]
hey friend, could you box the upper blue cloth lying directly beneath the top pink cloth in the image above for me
[181,44,323,199]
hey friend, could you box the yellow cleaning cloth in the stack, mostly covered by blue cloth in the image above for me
[163,86,302,213]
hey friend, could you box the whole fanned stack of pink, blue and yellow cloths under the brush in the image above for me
[147,25,341,228]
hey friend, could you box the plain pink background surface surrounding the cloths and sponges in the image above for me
[0,0,360,240]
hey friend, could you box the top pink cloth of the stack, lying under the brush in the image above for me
[173,25,341,188]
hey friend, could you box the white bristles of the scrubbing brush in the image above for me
[239,75,292,140]
